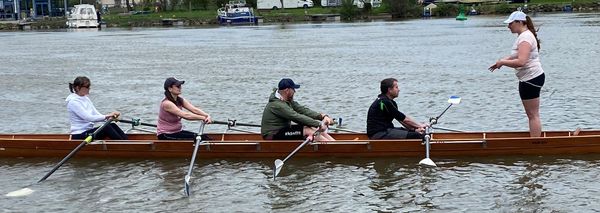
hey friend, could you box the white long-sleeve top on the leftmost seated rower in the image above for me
[65,93,106,134]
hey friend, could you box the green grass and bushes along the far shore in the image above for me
[0,0,600,31]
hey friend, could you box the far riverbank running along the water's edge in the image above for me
[0,0,600,31]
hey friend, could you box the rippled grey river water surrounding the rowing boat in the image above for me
[0,13,600,212]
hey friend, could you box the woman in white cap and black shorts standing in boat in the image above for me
[489,11,545,137]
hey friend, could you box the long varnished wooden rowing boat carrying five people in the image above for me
[0,130,600,158]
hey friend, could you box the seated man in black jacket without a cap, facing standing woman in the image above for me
[367,78,427,139]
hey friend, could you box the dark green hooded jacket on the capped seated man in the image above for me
[260,89,323,137]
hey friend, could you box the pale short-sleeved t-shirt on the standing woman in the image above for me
[511,30,544,81]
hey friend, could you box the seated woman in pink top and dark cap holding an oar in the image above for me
[156,77,212,140]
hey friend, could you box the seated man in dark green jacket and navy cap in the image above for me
[260,78,335,141]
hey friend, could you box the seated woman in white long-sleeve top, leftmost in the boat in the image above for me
[65,76,127,140]
